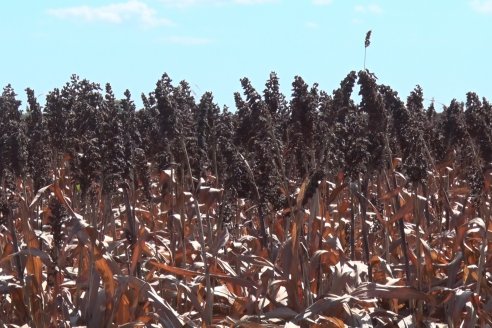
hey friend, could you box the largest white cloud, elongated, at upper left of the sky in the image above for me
[48,0,172,27]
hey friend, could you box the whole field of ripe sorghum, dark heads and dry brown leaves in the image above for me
[0,70,492,328]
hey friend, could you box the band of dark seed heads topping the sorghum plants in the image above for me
[0,70,492,232]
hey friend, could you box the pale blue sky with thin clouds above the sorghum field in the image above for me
[0,0,492,106]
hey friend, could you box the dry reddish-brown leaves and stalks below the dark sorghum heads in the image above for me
[0,158,492,327]
